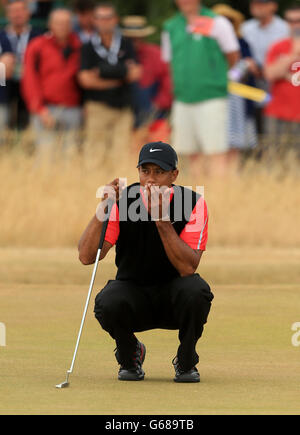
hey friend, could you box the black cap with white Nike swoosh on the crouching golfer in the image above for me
[137,142,178,171]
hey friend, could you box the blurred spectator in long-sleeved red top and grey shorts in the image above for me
[22,9,82,162]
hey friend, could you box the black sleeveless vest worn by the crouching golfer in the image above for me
[116,183,201,285]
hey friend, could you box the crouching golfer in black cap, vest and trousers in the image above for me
[79,142,214,383]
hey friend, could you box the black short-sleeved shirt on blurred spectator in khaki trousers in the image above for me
[80,37,136,108]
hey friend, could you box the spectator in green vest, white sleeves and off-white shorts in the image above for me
[162,0,240,176]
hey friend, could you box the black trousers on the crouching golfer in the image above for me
[95,275,214,371]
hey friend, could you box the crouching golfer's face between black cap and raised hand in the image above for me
[139,163,178,187]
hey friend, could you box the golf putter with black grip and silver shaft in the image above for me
[56,200,114,389]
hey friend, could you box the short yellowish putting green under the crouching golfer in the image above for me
[0,248,300,415]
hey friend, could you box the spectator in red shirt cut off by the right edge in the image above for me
[265,4,300,156]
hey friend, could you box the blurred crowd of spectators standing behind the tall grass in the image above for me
[0,0,300,174]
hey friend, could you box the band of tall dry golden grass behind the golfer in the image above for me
[0,150,300,247]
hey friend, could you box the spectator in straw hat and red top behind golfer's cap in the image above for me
[122,16,173,152]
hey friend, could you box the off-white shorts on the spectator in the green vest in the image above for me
[172,98,229,155]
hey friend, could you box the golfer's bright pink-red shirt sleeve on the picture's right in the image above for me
[180,197,208,251]
